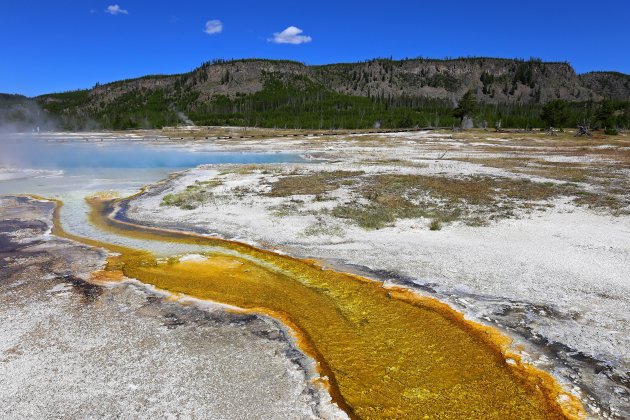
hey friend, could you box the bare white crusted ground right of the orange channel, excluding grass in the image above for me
[126,133,630,418]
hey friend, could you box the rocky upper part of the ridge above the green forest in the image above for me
[41,58,630,108]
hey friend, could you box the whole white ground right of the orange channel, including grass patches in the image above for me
[121,131,630,418]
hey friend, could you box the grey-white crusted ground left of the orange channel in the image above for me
[0,196,346,419]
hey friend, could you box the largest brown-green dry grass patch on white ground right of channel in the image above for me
[330,174,575,229]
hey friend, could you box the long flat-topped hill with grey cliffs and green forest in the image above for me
[8,58,630,129]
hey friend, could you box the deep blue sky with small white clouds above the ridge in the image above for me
[0,0,630,95]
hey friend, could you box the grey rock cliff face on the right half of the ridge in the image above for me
[318,58,602,103]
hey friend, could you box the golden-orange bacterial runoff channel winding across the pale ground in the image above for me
[53,195,581,418]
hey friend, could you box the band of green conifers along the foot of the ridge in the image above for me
[34,74,630,133]
